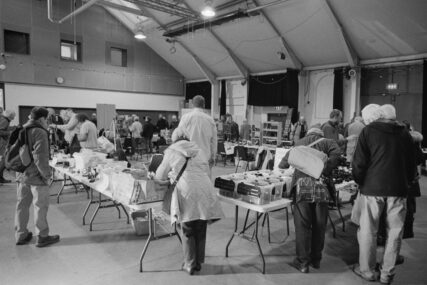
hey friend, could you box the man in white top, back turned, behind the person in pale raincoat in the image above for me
[178,95,218,177]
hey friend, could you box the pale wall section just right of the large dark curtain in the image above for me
[299,69,334,126]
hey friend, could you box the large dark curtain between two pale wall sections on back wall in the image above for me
[248,69,298,122]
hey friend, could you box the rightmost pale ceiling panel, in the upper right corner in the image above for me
[331,0,427,59]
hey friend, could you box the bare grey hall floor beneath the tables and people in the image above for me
[0,165,427,285]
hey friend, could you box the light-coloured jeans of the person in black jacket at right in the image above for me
[357,194,406,280]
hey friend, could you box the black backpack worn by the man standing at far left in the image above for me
[4,125,44,173]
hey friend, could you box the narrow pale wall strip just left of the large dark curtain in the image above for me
[226,80,248,126]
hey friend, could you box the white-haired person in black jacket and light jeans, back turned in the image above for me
[352,105,415,284]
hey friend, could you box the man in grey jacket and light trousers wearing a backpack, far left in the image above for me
[15,107,59,247]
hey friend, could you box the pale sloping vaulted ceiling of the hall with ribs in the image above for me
[91,0,427,80]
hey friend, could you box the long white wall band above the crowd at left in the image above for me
[5,83,183,123]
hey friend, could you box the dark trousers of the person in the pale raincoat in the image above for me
[181,220,207,268]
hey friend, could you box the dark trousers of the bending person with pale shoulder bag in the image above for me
[294,202,328,266]
